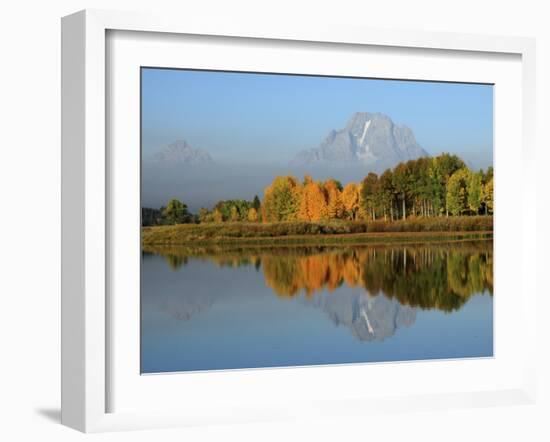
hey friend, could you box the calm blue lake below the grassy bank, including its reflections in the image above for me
[141,241,493,373]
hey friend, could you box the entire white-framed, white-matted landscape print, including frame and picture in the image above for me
[62,11,536,431]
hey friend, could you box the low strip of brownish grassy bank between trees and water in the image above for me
[142,216,493,246]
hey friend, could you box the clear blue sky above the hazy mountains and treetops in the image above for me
[142,68,493,167]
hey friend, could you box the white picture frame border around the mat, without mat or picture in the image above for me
[62,10,537,432]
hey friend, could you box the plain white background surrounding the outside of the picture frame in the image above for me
[0,0,550,441]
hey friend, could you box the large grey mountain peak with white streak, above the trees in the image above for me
[291,112,428,169]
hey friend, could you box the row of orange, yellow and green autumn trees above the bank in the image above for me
[142,153,494,225]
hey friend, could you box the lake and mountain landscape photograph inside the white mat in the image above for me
[140,67,495,374]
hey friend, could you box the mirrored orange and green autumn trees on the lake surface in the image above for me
[144,241,493,312]
